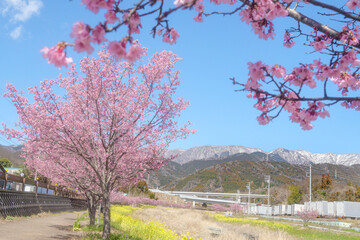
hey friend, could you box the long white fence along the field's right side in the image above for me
[244,201,360,218]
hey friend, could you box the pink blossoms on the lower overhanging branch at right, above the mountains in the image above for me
[244,61,338,130]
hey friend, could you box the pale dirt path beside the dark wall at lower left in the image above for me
[0,212,81,240]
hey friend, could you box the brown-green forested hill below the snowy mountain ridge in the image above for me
[150,152,360,203]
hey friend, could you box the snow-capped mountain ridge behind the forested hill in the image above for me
[166,145,360,166]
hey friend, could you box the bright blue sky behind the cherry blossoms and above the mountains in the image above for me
[0,0,360,154]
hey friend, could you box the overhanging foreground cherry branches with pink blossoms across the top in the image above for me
[42,0,360,130]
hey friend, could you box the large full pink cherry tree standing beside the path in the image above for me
[2,50,195,238]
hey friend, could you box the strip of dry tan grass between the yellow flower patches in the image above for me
[133,207,296,240]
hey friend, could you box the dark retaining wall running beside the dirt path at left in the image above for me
[0,190,86,218]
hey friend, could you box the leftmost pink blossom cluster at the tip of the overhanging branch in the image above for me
[40,44,72,68]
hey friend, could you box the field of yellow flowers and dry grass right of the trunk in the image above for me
[76,206,360,240]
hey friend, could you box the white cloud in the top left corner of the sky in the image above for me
[1,0,43,22]
